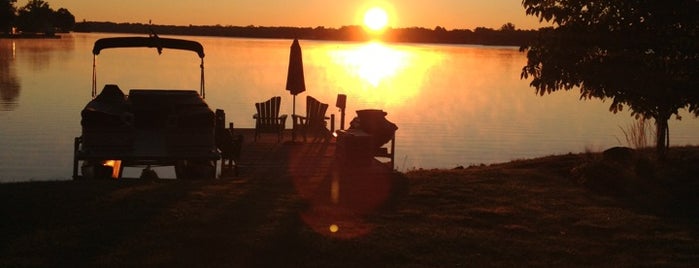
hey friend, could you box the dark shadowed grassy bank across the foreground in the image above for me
[0,148,699,267]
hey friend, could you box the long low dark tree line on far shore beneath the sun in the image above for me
[74,21,538,46]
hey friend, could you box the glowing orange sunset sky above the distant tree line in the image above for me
[49,0,543,29]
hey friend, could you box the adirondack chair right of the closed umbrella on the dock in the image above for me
[293,96,331,142]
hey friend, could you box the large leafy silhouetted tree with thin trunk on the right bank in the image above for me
[521,0,699,158]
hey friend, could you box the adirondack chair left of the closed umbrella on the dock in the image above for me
[252,96,286,141]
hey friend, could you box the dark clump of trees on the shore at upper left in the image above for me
[0,0,75,33]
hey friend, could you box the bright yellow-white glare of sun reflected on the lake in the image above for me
[327,42,442,106]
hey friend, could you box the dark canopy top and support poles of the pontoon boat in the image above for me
[92,34,206,98]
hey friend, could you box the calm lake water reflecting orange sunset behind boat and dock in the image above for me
[0,33,699,182]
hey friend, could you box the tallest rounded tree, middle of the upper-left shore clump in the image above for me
[17,0,53,32]
